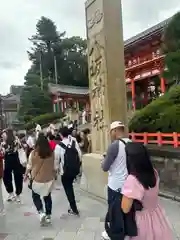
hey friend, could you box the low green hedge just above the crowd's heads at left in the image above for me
[24,113,64,130]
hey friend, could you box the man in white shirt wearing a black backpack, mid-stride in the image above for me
[59,127,82,215]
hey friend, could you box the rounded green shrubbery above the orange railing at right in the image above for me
[129,86,180,133]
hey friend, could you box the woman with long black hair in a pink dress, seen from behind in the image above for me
[121,143,173,240]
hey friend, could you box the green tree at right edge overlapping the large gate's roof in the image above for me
[162,12,180,86]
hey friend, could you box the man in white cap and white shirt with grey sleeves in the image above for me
[102,121,130,240]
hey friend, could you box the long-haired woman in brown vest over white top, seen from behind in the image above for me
[25,133,59,225]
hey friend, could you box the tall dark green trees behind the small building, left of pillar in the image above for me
[19,17,88,122]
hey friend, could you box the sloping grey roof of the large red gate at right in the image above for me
[124,18,171,49]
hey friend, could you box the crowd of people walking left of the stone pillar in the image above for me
[0,125,90,224]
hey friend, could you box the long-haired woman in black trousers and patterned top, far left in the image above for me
[2,129,23,202]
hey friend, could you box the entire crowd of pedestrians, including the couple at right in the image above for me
[0,121,172,240]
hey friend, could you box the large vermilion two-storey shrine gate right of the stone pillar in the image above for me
[124,19,169,110]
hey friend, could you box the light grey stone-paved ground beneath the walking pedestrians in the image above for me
[0,181,180,240]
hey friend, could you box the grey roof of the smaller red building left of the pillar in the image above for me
[48,83,89,95]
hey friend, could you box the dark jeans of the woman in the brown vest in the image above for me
[32,191,52,215]
